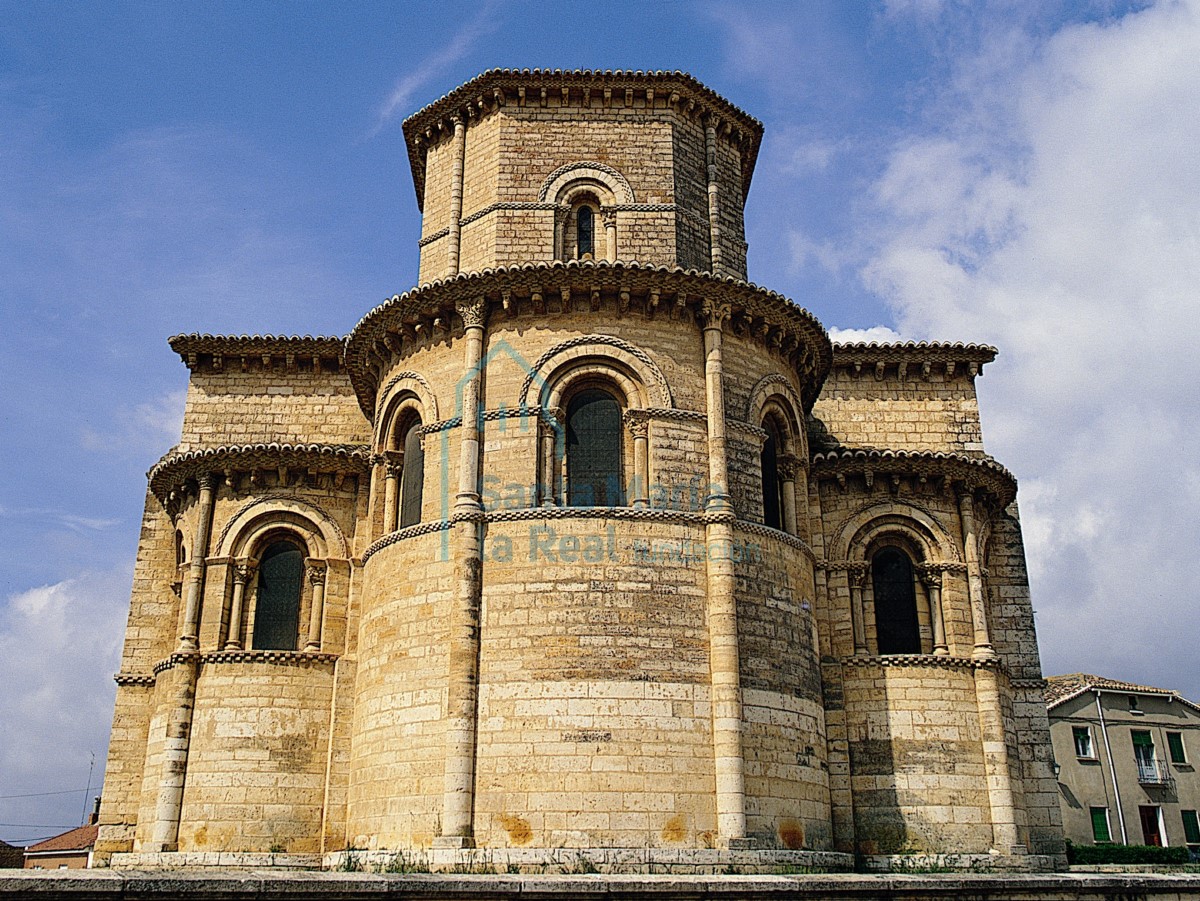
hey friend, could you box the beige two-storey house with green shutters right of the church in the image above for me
[1046,673,1200,853]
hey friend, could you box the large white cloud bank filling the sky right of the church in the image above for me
[863,2,1200,697]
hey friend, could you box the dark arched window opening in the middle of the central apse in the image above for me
[566,388,624,506]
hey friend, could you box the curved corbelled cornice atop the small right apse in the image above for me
[811,448,1016,507]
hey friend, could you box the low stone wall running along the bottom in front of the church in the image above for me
[0,870,1200,901]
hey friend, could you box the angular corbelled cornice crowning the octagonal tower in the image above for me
[403,68,762,209]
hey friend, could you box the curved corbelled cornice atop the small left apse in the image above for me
[146,443,370,503]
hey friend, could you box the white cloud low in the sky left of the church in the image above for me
[0,567,131,841]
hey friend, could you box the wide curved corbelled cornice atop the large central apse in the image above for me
[346,260,833,420]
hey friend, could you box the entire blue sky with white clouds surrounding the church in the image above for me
[0,0,1200,841]
